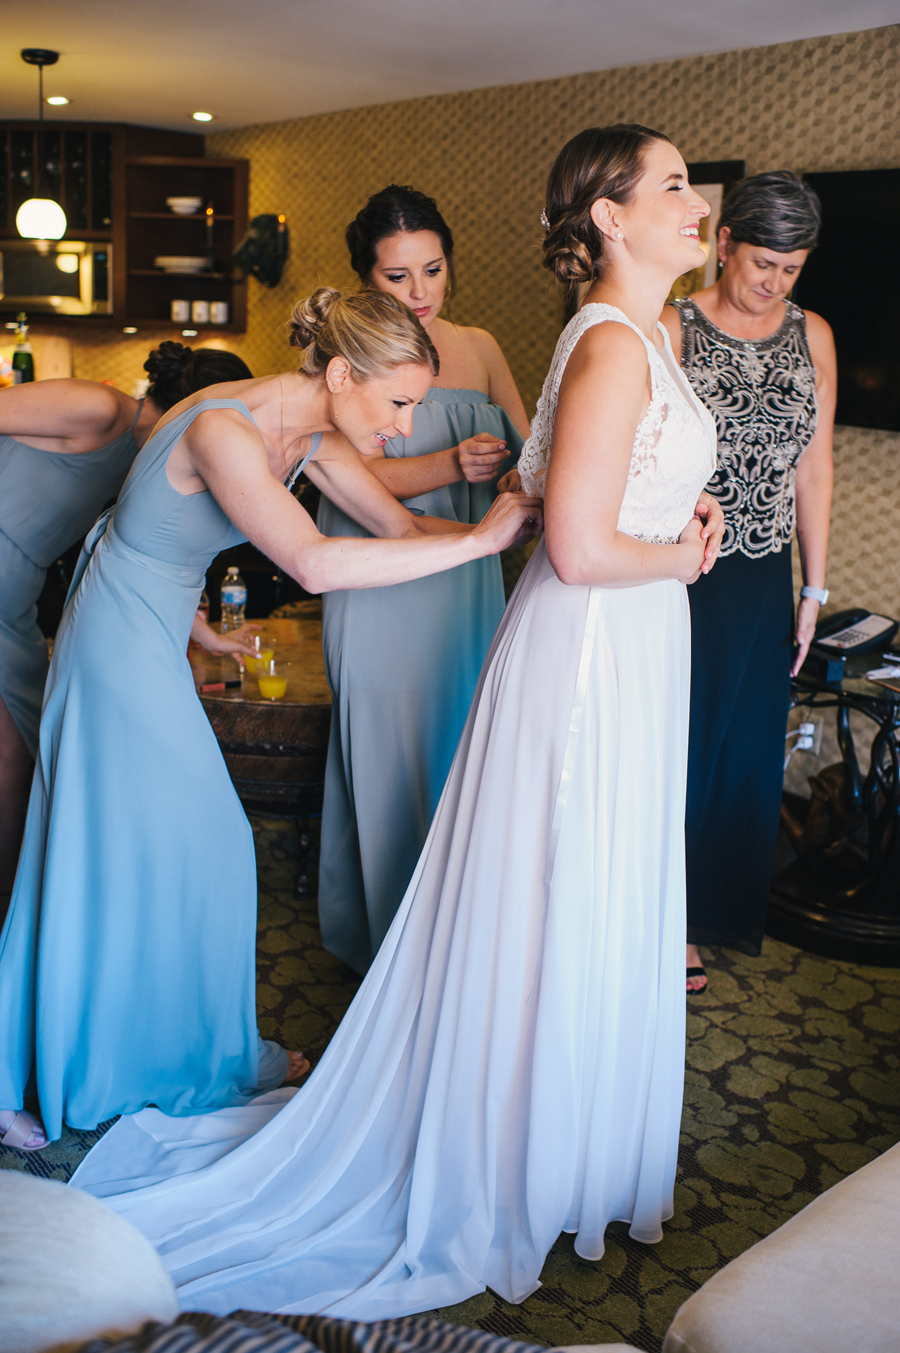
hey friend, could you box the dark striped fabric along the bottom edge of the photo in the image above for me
[78,1311,544,1353]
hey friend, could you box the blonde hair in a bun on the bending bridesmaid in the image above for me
[288,287,440,383]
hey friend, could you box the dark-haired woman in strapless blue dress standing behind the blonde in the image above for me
[318,184,528,973]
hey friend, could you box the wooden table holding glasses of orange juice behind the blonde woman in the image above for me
[188,618,332,897]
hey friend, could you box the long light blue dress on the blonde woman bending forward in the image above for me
[0,399,309,1138]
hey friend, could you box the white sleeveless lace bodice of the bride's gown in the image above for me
[518,303,716,544]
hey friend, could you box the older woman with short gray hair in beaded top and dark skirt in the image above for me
[662,170,836,992]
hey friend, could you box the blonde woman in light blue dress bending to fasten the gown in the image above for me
[0,288,540,1138]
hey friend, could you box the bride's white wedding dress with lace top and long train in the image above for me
[73,304,716,1319]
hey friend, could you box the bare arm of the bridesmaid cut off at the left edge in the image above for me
[0,376,137,453]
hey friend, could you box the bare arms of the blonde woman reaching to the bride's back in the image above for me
[183,409,540,593]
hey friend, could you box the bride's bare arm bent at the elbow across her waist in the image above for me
[544,321,705,587]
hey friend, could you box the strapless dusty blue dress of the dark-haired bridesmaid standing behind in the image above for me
[318,388,522,973]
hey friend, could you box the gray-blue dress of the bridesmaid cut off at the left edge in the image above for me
[0,400,143,756]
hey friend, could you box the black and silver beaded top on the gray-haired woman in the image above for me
[675,296,819,559]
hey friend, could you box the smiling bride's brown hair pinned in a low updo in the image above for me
[543,122,671,288]
